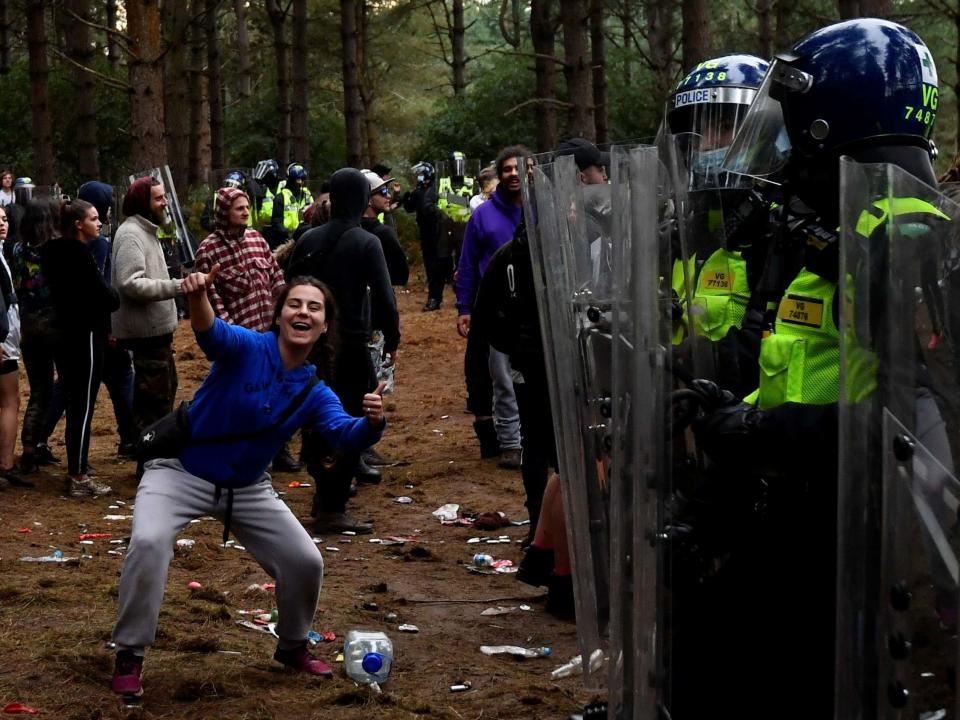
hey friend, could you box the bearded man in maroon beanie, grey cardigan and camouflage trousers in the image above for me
[111,176,182,434]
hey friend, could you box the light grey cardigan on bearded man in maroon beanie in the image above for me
[112,215,182,340]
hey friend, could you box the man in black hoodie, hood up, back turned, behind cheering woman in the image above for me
[287,168,400,534]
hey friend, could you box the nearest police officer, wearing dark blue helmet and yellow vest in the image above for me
[672,19,942,720]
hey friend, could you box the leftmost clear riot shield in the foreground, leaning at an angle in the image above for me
[525,156,612,687]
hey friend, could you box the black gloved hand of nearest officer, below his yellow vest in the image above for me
[693,391,767,465]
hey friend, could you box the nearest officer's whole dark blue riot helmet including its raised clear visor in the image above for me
[724,18,939,222]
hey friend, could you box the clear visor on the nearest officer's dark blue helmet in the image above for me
[723,59,797,185]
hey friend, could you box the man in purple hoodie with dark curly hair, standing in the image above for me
[454,145,530,469]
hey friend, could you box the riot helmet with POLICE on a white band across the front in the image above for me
[661,54,768,190]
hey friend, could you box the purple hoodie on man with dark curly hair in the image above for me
[454,186,523,315]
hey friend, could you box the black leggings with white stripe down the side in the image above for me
[55,332,105,475]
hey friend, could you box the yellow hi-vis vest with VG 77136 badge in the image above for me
[681,248,750,342]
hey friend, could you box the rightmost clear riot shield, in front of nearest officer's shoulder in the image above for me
[835,159,960,720]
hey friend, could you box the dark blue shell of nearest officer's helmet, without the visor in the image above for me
[784,18,940,155]
